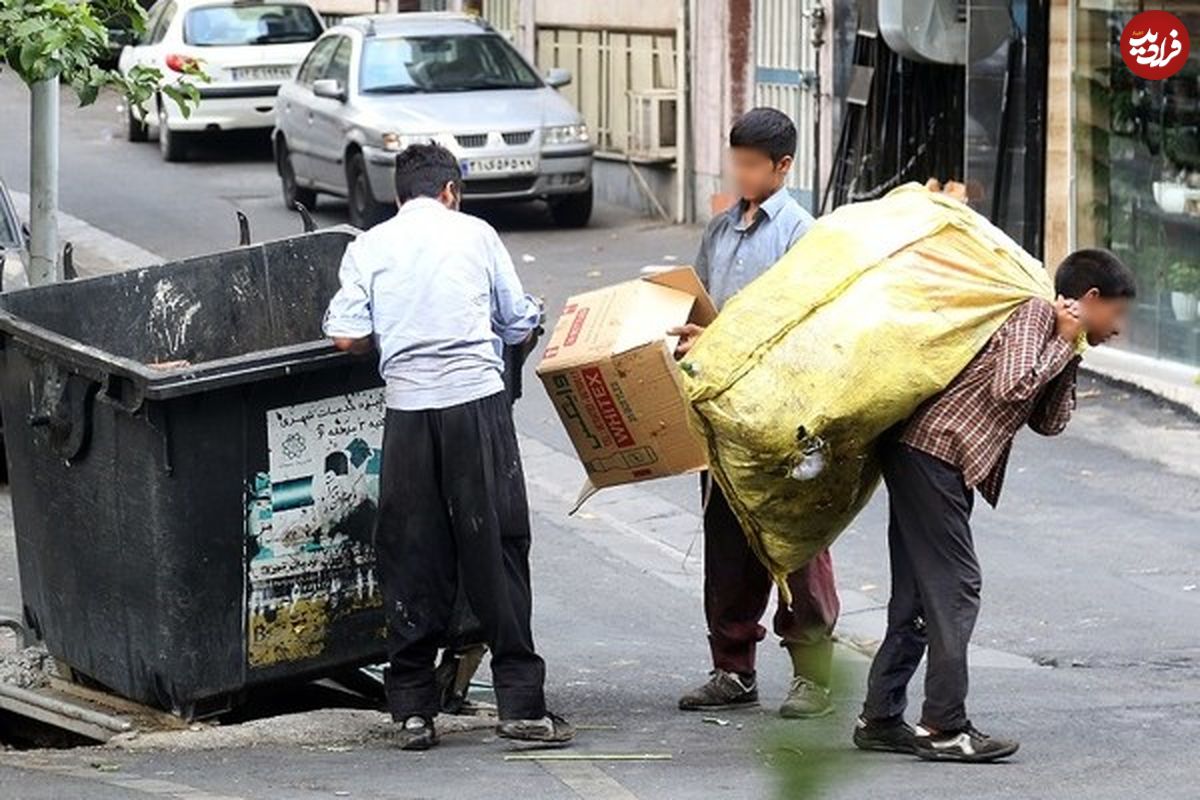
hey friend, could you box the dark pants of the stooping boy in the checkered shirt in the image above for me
[863,443,982,730]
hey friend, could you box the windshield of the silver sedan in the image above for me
[359,35,542,94]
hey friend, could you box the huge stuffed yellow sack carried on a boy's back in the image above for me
[682,184,1054,585]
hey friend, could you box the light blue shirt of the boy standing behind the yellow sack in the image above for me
[696,186,814,308]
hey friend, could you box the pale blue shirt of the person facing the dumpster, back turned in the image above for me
[324,198,541,411]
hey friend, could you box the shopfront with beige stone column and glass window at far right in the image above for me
[1046,0,1200,367]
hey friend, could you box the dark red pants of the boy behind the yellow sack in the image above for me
[702,475,841,686]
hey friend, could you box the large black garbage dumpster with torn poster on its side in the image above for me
[0,228,384,717]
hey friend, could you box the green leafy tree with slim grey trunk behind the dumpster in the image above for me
[0,0,203,283]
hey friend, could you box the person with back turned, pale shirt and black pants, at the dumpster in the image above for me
[325,144,574,750]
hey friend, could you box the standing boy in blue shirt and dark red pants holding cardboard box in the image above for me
[671,108,839,717]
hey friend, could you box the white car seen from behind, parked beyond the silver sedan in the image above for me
[118,0,323,161]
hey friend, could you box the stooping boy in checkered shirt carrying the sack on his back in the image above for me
[854,249,1136,762]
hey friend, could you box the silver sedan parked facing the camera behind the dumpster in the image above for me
[274,13,593,228]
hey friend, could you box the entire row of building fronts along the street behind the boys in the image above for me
[463,0,1200,367]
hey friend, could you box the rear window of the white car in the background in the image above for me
[184,2,320,47]
